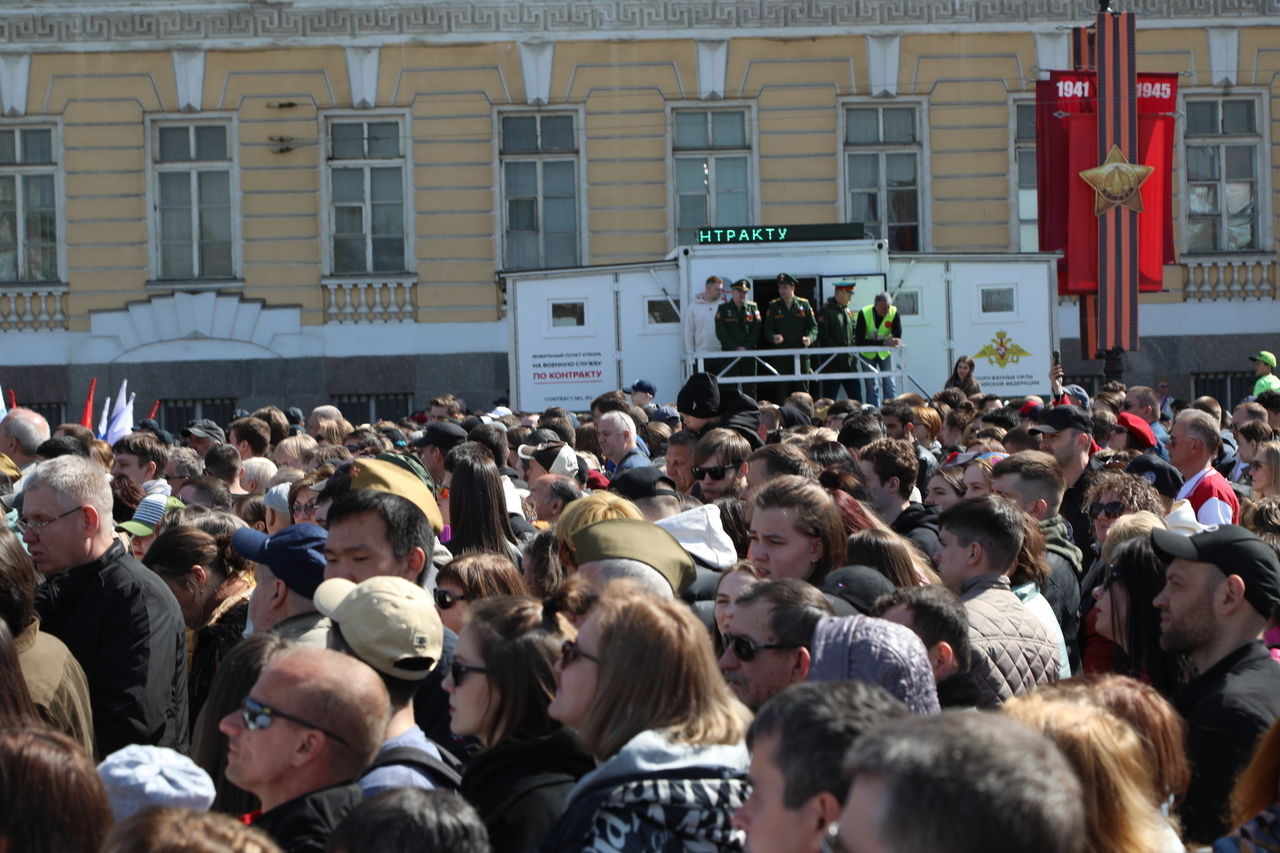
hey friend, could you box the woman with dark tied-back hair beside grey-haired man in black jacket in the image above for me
[142,522,253,727]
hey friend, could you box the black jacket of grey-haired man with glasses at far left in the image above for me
[36,542,189,757]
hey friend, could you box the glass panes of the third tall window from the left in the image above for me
[329,118,408,274]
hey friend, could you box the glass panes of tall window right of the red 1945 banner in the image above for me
[1184,97,1262,252]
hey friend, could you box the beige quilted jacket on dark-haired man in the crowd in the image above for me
[960,574,1059,708]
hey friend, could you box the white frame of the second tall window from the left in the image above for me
[145,113,243,286]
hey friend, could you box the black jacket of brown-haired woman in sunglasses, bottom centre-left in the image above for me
[461,733,595,853]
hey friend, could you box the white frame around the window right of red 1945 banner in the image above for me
[1175,86,1275,257]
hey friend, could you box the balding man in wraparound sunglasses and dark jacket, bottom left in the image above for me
[218,647,390,853]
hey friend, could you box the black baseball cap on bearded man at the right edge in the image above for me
[1151,524,1280,617]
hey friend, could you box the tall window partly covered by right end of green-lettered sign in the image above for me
[845,104,920,252]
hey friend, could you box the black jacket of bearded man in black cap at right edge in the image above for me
[1174,640,1280,844]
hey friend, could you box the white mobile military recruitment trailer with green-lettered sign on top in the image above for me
[498,225,1059,411]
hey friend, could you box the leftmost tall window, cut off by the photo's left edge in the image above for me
[0,127,58,282]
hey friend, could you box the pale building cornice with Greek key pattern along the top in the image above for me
[0,0,1280,53]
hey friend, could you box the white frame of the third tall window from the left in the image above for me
[317,109,417,278]
